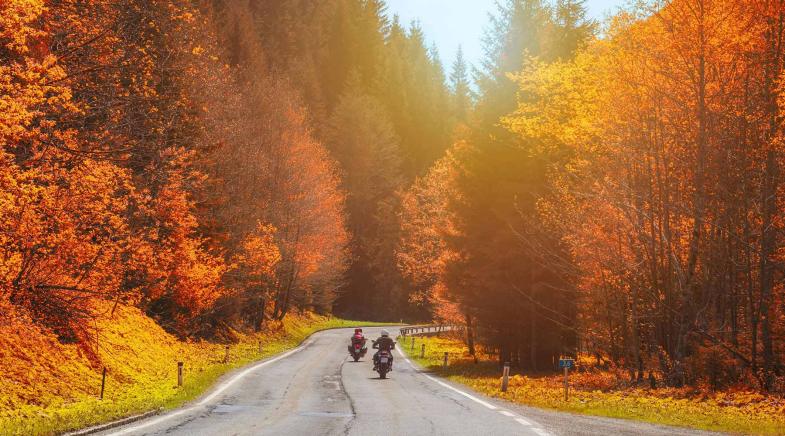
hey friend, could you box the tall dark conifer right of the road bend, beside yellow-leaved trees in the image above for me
[432,0,592,369]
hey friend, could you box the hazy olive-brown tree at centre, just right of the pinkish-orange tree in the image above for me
[326,89,403,319]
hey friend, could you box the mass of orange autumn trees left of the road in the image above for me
[0,1,348,339]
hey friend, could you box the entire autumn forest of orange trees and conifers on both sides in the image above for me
[0,0,785,398]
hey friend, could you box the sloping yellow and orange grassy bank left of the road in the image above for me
[0,307,392,435]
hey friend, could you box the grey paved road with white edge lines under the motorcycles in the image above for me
[104,329,720,436]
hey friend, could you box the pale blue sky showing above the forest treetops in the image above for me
[387,0,625,70]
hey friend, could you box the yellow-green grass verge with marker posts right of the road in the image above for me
[398,337,785,435]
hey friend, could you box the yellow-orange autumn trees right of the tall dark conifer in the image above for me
[505,0,781,388]
